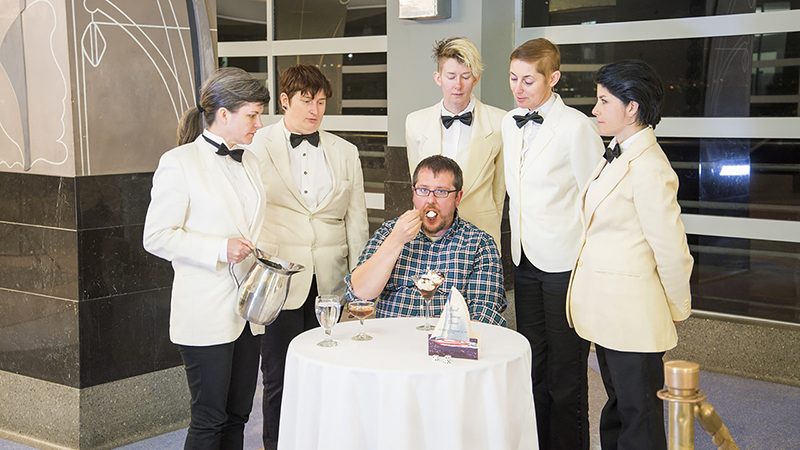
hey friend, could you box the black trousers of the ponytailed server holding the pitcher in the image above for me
[178,324,260,450]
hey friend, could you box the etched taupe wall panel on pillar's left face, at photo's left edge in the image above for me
[0,0,74,175]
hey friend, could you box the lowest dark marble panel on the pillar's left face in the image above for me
[0,289,80,387]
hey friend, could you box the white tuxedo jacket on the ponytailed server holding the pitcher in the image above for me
[143,136,264,346]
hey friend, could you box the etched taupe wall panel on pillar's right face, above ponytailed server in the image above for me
[72,0,206,175]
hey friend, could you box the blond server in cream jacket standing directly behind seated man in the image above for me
[406,37,506,249]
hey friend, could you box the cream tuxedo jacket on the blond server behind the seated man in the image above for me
[406,101,506,249]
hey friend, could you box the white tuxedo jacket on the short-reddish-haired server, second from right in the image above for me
[502,94,605,272]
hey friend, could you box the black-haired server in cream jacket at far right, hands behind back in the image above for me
[567,61,693,450]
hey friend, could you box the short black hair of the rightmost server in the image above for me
[594,59,664,128]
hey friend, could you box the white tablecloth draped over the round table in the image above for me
[278,318,538,450]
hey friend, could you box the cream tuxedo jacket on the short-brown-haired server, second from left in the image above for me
[250,121,369,309]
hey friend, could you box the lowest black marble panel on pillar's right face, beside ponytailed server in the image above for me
[79,288,181,388]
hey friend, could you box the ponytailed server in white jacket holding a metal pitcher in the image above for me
[144,68,269,449]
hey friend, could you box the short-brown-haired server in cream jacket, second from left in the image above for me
[251,64,369,449]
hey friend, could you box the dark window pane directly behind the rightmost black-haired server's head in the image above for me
[556,32,800,117]
